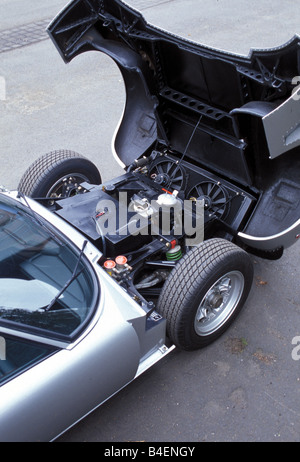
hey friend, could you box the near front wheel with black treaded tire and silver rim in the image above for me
[157,239,253,350]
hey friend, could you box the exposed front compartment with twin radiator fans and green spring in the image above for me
[55,149,256,306]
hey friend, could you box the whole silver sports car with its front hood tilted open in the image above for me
[0,0,300,441]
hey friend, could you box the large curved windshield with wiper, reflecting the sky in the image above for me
[0,196,97,337]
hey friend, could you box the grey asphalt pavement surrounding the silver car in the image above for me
[0,0,300,442]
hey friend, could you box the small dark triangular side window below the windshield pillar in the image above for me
[0,332,55,386]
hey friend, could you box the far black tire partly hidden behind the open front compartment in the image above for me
[18,150,101,198]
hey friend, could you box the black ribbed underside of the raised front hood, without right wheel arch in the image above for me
[48,0,300,185]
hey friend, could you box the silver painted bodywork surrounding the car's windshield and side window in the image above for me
[0,190,173,441]
